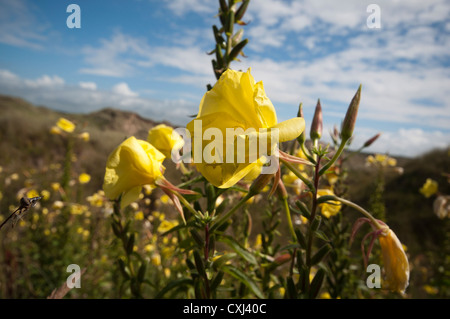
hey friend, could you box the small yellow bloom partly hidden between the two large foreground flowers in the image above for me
[147,124,184,158]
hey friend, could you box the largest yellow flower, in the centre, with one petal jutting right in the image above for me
[187,69,305,188]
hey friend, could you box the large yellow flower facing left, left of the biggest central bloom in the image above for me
[103,136,164,208]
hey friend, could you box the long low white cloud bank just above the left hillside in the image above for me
[0,69,198,126]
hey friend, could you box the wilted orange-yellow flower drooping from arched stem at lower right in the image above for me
[378,228,409,293]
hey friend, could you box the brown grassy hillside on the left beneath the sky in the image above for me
[0,95,179,204]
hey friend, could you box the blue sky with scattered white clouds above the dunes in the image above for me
[0,0,450,156]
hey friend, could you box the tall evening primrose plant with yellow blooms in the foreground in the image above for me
[96,0,409,299]
